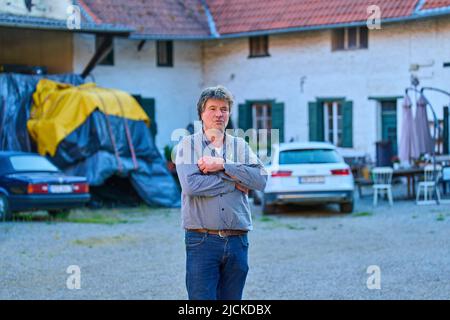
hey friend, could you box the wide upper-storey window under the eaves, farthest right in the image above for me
[332,27,369,51]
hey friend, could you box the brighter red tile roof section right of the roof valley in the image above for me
[207,0,418,34]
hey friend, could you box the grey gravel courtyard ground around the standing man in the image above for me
[0,192,450,299]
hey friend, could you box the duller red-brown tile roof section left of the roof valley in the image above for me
[79,0,210,38]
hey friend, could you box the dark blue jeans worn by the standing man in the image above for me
[185,231,248,300]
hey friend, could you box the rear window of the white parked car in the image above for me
[279,149,341,164]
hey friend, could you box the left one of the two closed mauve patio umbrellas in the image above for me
[399,95,420,163]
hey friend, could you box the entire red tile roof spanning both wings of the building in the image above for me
[78,0,450,39]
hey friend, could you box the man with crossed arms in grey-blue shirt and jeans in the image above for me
[176,86,267,300]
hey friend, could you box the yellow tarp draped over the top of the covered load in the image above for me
[27,79,150,156]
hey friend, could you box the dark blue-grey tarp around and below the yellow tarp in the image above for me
[0,74,180,207]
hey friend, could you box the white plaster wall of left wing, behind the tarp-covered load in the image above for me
[74,34,202,150]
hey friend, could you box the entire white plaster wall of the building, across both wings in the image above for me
[74,18,450,156]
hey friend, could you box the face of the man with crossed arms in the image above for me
[201,99,230,132]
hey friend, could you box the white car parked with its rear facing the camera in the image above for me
[262,142,355,214]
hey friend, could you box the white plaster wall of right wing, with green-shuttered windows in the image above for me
[203,19,450,156]
